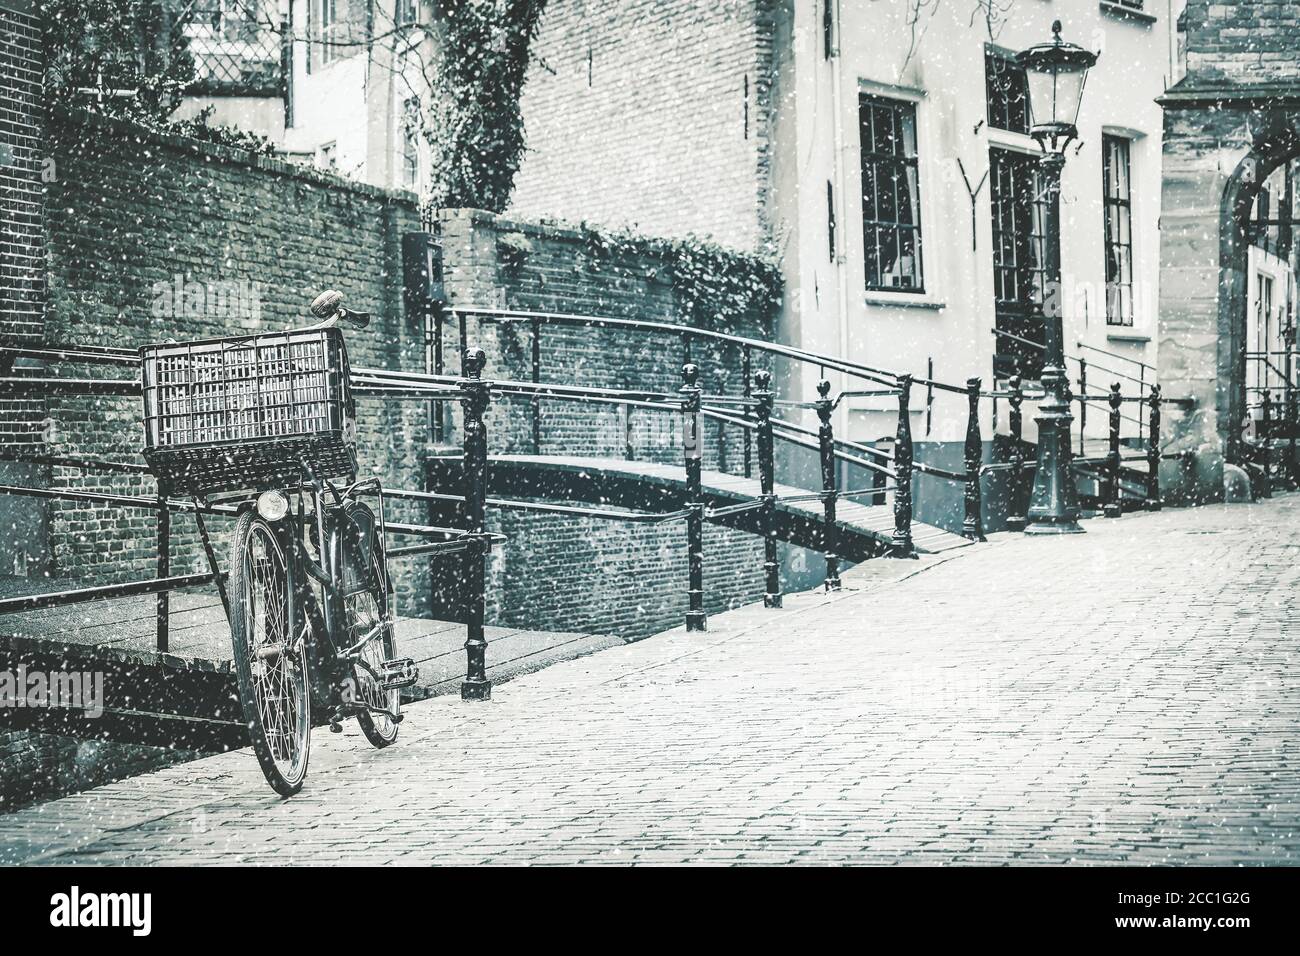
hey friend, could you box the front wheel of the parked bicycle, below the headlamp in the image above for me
[230,511,311,796]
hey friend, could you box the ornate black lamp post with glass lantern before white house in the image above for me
[1017,20,1097,535]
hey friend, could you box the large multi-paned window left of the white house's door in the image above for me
[858,94,924,293]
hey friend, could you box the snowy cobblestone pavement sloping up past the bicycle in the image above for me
[0,496,1300,864]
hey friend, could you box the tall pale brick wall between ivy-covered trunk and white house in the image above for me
[511,0,775,251]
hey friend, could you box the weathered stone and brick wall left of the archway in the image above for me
[1160,0,1300,499]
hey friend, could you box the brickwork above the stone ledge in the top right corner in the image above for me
[1186,0,1300,85]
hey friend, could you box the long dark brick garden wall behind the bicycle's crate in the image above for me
[36,106,426,606]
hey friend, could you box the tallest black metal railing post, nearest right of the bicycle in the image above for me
[460,349,491,700]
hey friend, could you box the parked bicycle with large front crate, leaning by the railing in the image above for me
[140,291,419,797]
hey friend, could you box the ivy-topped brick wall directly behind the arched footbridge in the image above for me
[439,209,774,637]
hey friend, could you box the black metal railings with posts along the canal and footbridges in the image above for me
[0,310,1190,698]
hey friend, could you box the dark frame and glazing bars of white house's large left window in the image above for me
[858,87,932,297]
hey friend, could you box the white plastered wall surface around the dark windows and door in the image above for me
[774,0,1177,452]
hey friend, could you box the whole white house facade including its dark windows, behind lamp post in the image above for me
[774,0,1179,442]
